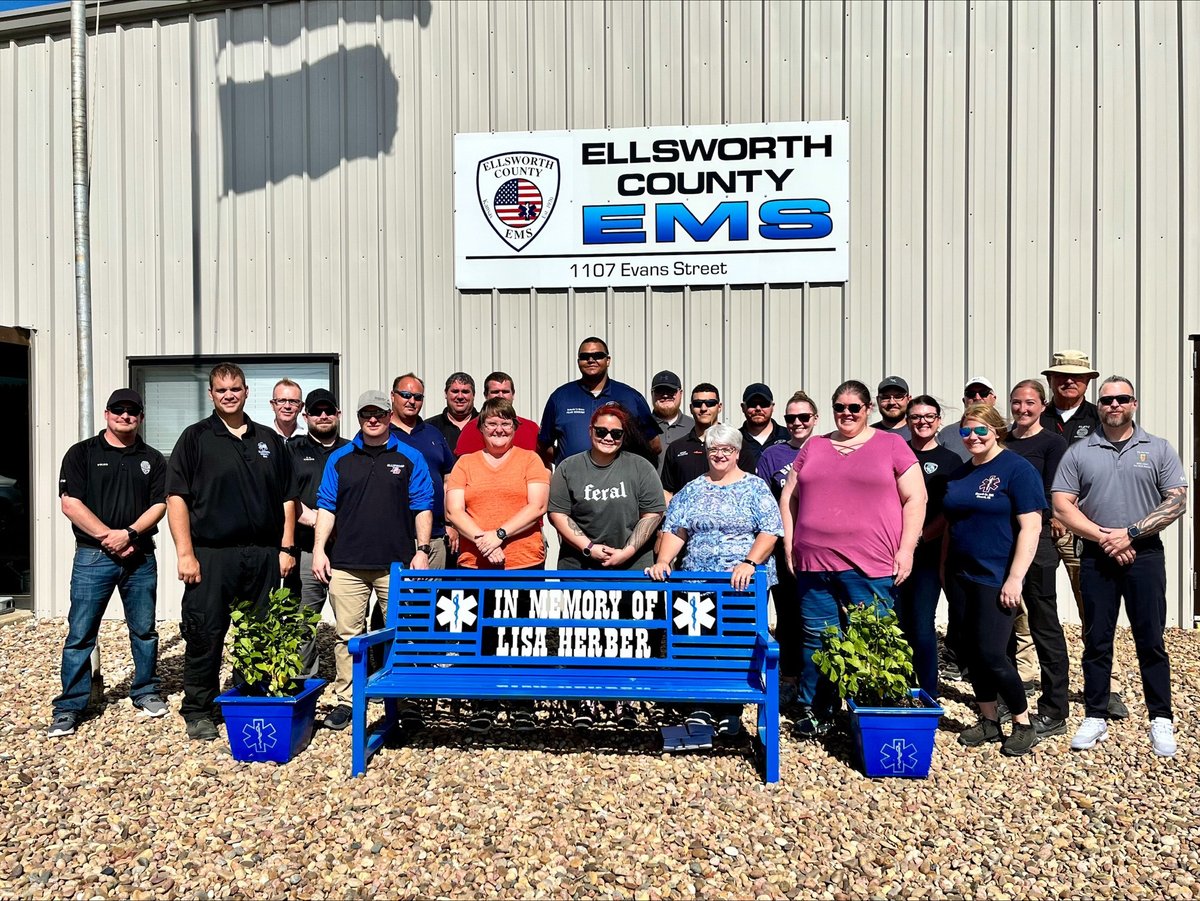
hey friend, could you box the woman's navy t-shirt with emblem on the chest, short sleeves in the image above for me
[942,450,1046,588]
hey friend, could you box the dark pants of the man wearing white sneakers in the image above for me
[1079,542,1174,720]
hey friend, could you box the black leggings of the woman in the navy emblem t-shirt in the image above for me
[946,572,1028,716]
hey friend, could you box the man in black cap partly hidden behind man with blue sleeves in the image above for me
[283,388,349,678]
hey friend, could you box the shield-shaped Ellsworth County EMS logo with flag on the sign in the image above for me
[475,150,562,252]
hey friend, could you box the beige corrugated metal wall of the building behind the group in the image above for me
[0,0,1200,620]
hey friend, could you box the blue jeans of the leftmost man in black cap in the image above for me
[54,547,158,714]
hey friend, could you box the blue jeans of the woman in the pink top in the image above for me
[796,570,895,719]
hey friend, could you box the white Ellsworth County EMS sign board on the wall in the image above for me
[454,121,850,289]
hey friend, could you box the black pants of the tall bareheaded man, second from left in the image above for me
[179,547,280,722]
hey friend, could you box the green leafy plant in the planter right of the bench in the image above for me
[812,603,913,707]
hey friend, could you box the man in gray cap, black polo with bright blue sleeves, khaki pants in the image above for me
[312,391,433,729]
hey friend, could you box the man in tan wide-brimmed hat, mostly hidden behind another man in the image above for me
[1042,350,1129,720]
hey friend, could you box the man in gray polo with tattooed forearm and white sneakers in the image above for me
[1051,376,1188,757]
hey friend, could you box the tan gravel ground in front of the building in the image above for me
[0,620,1200,899]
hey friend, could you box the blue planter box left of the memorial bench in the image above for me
[217,679,326,763]
